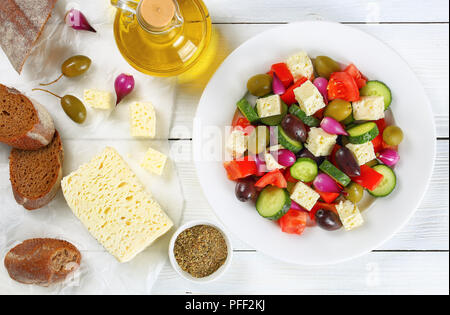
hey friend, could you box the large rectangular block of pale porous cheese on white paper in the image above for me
[61,147,173,262]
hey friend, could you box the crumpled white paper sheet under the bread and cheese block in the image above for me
[0,0,183,294]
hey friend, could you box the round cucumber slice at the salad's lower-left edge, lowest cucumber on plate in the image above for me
[256,186,291,220]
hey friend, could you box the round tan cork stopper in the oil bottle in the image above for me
[140,0,176,28]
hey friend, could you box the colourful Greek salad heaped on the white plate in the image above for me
[224,52,404,235]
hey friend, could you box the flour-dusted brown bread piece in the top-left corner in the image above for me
[0,0,58,74]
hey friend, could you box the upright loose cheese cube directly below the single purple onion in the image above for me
[130,102,156,138]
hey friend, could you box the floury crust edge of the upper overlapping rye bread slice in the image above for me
[0,84,55,150]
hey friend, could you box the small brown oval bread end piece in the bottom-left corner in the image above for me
[4,238,81,287]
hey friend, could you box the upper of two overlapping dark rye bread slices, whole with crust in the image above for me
[0,84,55,150]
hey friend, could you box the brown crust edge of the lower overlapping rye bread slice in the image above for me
[9,132,64,211]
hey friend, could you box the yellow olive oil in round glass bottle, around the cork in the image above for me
[114,0,212,77]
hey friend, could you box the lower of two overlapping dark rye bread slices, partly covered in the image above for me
[9,132,64,210]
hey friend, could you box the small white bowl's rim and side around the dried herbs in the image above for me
[169,220,233,283]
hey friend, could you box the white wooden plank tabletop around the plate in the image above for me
[153,0,449,294]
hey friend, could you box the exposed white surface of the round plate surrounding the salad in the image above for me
[194,22,436,265]
